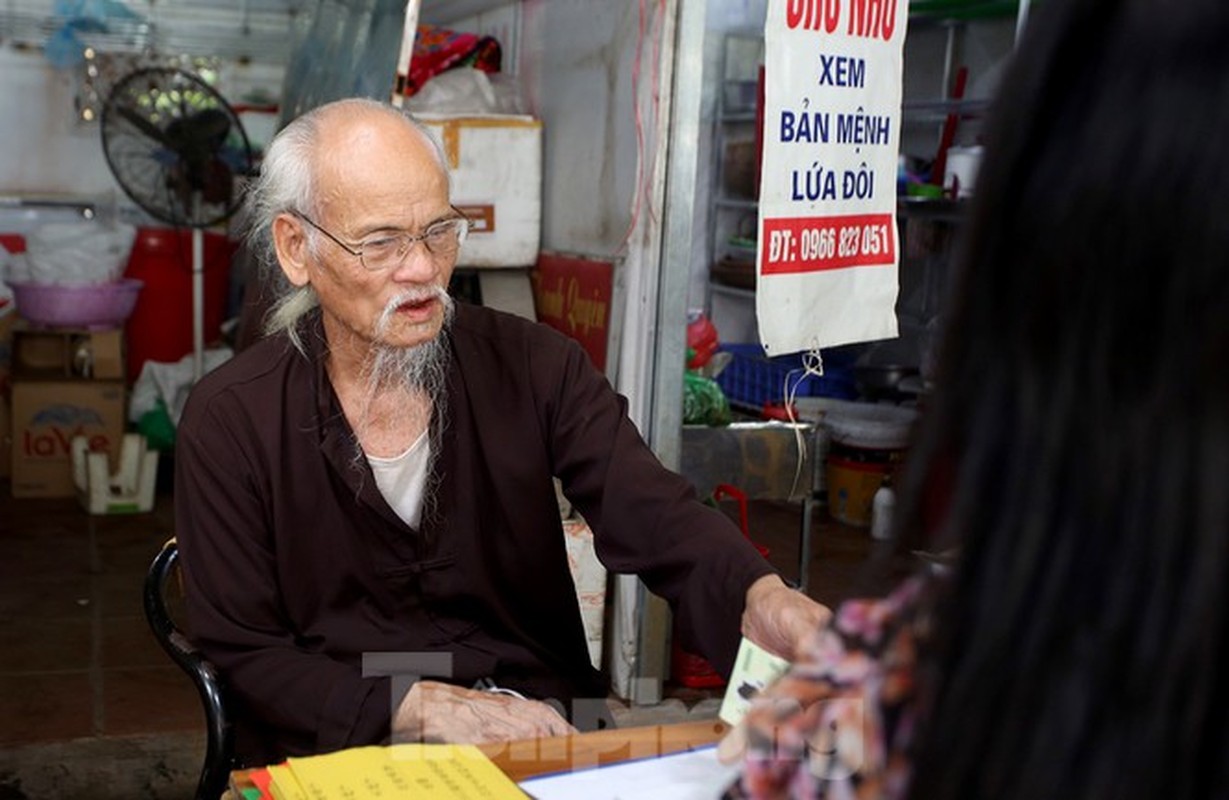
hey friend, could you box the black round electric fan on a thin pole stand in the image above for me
[101,68,252,380]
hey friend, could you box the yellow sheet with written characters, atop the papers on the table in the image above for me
[288,745,526,800]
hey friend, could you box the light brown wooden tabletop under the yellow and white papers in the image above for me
[231,719,729,800]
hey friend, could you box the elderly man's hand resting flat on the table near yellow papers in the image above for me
[392,681,576,745]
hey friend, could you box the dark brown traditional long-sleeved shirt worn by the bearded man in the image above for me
[176,305,772,763]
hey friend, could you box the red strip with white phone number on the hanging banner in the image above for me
[760,214,896,275]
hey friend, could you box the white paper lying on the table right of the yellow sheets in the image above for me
[520,746,740,800]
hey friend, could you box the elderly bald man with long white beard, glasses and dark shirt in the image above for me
[176,100,827,763]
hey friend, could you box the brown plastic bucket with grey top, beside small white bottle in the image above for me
[823,403,917,527]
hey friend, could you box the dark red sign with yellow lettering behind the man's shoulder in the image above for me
[530,253,615,370]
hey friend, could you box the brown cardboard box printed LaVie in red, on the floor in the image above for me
[12,376,124,498]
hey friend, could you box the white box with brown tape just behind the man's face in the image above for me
[419,114,542,267]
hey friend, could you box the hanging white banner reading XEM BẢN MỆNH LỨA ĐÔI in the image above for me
[756,0,908,355]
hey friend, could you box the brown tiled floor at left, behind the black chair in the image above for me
[0,487,199,746]
